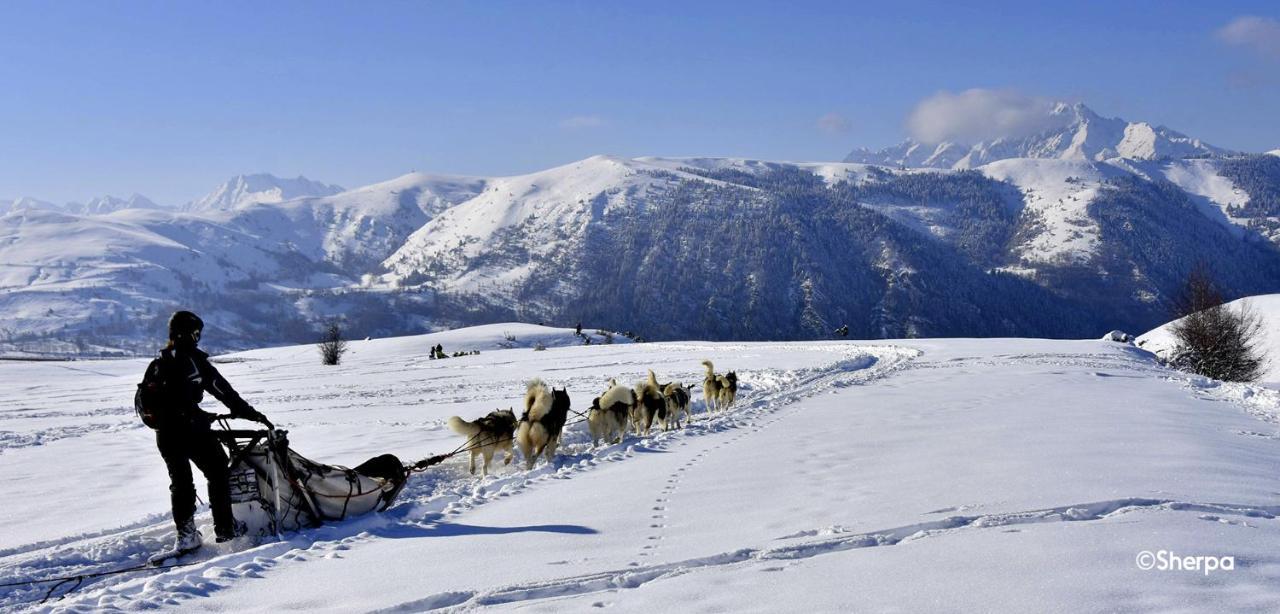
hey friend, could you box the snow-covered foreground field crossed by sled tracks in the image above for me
[0,325,1280,613]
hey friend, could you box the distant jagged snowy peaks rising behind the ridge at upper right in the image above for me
[845,102,1229,169]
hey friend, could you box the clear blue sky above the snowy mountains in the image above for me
[0,1,1280,203]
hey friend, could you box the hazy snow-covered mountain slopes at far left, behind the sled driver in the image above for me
[0,174,484,354]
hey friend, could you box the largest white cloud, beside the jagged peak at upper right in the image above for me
[906,88,1068,143]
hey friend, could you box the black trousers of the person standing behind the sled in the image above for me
[156,429,236,537]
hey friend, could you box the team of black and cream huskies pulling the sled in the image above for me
[448,361,737,476]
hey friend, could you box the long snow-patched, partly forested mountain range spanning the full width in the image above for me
[0,146,1280,353]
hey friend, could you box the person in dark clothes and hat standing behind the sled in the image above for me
[155,311,273,551]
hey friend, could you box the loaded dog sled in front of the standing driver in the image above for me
[214,430,411,537]
